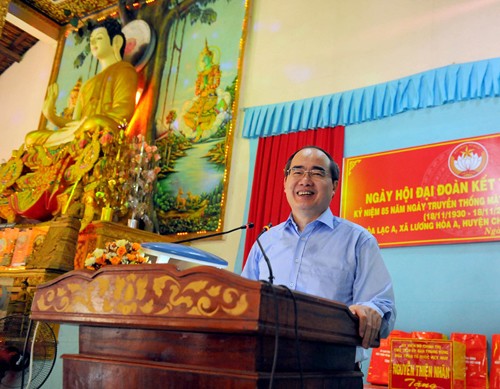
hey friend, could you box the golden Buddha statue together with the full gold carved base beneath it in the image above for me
[0,18,138,226]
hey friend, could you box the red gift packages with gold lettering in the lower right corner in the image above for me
[367,330,500,389]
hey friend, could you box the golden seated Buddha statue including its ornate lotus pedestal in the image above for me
[0,19,138,222]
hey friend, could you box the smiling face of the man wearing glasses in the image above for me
[284,149,338,220]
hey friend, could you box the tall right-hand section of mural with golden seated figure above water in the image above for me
[145,0,250,234]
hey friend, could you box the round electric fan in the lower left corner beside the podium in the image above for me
[0,315,57,389]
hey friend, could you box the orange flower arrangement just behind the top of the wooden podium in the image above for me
[85,239,149,270]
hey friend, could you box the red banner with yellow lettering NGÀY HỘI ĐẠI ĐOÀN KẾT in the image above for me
[341,134,500,247]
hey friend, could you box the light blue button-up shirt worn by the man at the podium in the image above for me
[241,208,396,361]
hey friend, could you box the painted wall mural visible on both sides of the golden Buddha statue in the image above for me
[41,0,249,235]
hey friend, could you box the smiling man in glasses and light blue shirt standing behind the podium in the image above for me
[241,146,396,362]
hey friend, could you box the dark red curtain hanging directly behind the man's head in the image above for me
[243,126,344,264]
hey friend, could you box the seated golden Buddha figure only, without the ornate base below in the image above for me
[25,19,137,147]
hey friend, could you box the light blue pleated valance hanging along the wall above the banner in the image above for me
[243,58,500,138]
